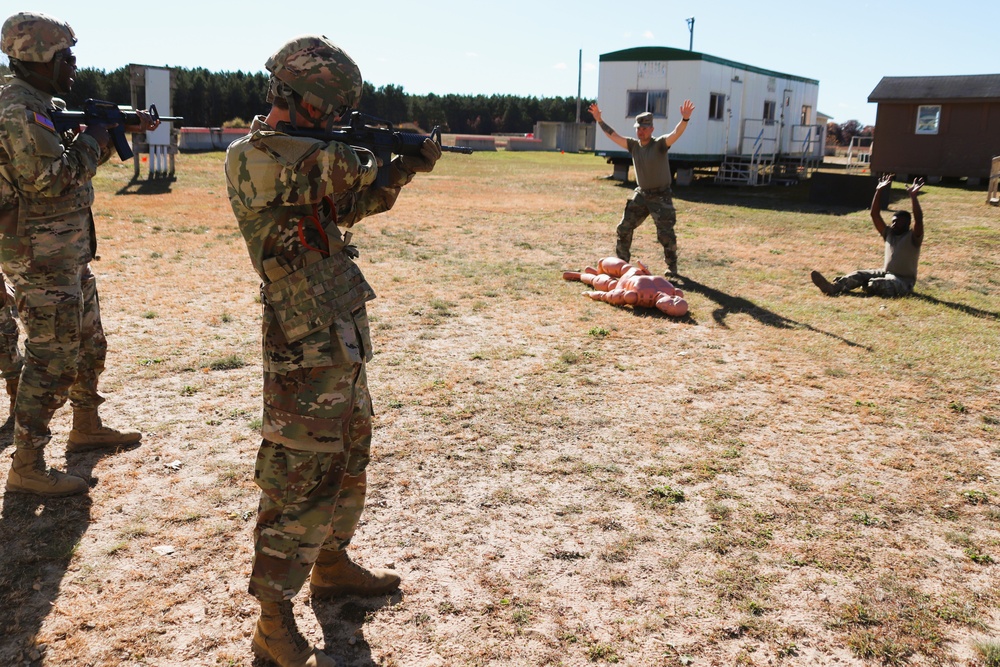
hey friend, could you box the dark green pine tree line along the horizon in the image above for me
[11,67,593,134]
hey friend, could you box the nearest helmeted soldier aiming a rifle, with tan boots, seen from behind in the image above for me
[226,36,441,667]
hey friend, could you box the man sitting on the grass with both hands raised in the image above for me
[809,174,924,297]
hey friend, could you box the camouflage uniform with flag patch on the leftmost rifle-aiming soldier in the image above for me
[0,74,111,450]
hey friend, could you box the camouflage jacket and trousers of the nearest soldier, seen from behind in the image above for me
[226,116,413,601]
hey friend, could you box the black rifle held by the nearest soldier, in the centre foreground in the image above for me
[275,111,472,187]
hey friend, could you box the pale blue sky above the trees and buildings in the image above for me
[8,0,1000,124]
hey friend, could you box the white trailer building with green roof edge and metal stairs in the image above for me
[595,46,826,185]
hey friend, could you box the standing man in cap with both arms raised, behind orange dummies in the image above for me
[590,100,694,277]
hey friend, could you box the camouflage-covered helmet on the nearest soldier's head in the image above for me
[264,35,364,114]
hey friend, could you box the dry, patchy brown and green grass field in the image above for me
[0,152,1000,667]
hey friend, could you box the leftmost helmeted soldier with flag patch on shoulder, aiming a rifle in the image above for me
[0,12,158,496]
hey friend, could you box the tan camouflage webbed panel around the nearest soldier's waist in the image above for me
[261,250,375,343]
